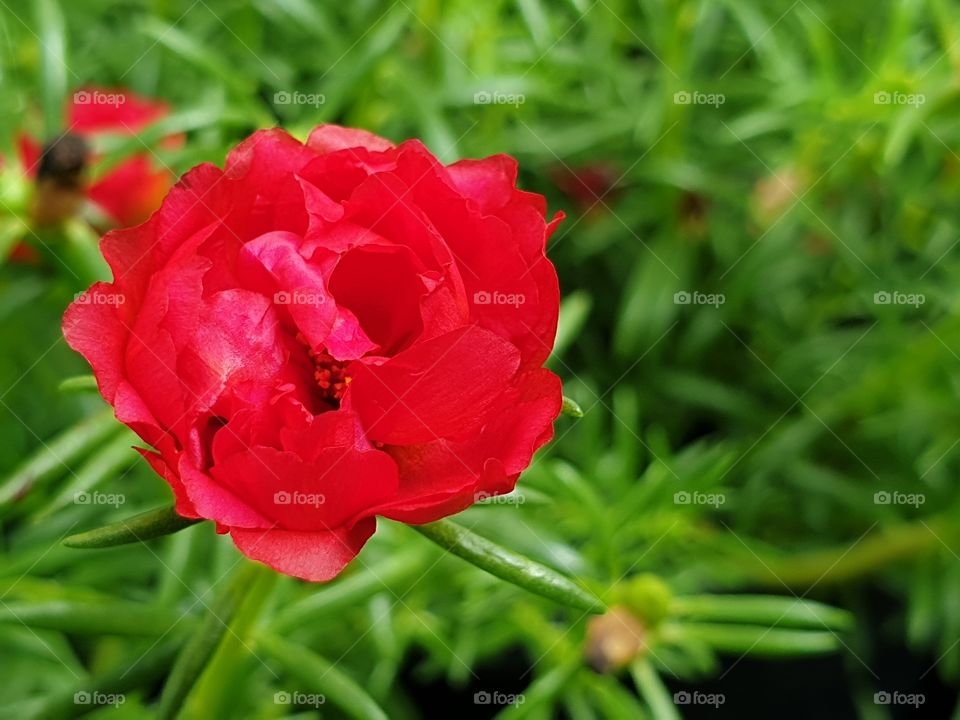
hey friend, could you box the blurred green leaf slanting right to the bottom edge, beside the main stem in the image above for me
[258,635,388,720]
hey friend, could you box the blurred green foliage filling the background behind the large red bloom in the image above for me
[0,0,960,720]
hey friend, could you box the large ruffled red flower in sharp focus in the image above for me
[64,125,561,580]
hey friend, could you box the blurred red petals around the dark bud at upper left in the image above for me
[18,88,173,227]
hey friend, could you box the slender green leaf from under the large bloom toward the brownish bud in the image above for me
[410,520,606,613]
